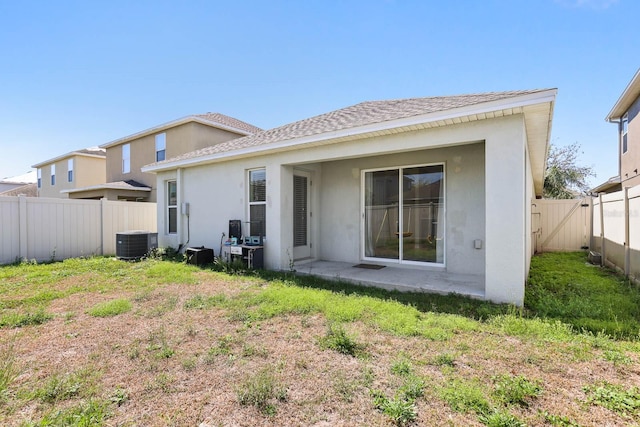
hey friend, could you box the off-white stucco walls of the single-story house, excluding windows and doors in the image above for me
[158,115,533,305]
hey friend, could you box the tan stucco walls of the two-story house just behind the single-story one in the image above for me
[107,122,243,202]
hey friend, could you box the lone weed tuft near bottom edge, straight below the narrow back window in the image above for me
[236,367,287,415]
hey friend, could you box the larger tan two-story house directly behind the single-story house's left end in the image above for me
[67,113,261,202]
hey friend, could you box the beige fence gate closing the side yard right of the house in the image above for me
[531,197,591,252]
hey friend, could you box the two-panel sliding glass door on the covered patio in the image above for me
[363,164,445,264]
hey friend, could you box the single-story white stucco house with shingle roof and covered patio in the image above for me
[142,89,556,305]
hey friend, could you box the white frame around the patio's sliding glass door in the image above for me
[360,162,447,268]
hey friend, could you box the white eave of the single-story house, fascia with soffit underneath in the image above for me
[142,89,557,179]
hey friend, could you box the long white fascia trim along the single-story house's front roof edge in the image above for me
[141,89,557,172]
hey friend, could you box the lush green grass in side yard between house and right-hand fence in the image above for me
[525,252,640,339]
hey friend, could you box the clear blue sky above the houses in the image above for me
[0,0,640,184]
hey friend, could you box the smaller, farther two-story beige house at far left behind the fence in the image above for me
[32,147,106,199]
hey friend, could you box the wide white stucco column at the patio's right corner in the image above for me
[485,116,531,306]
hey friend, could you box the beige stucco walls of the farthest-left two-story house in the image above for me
[38,155,106,199]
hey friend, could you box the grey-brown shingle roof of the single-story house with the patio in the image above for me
[154,89,547,166]
